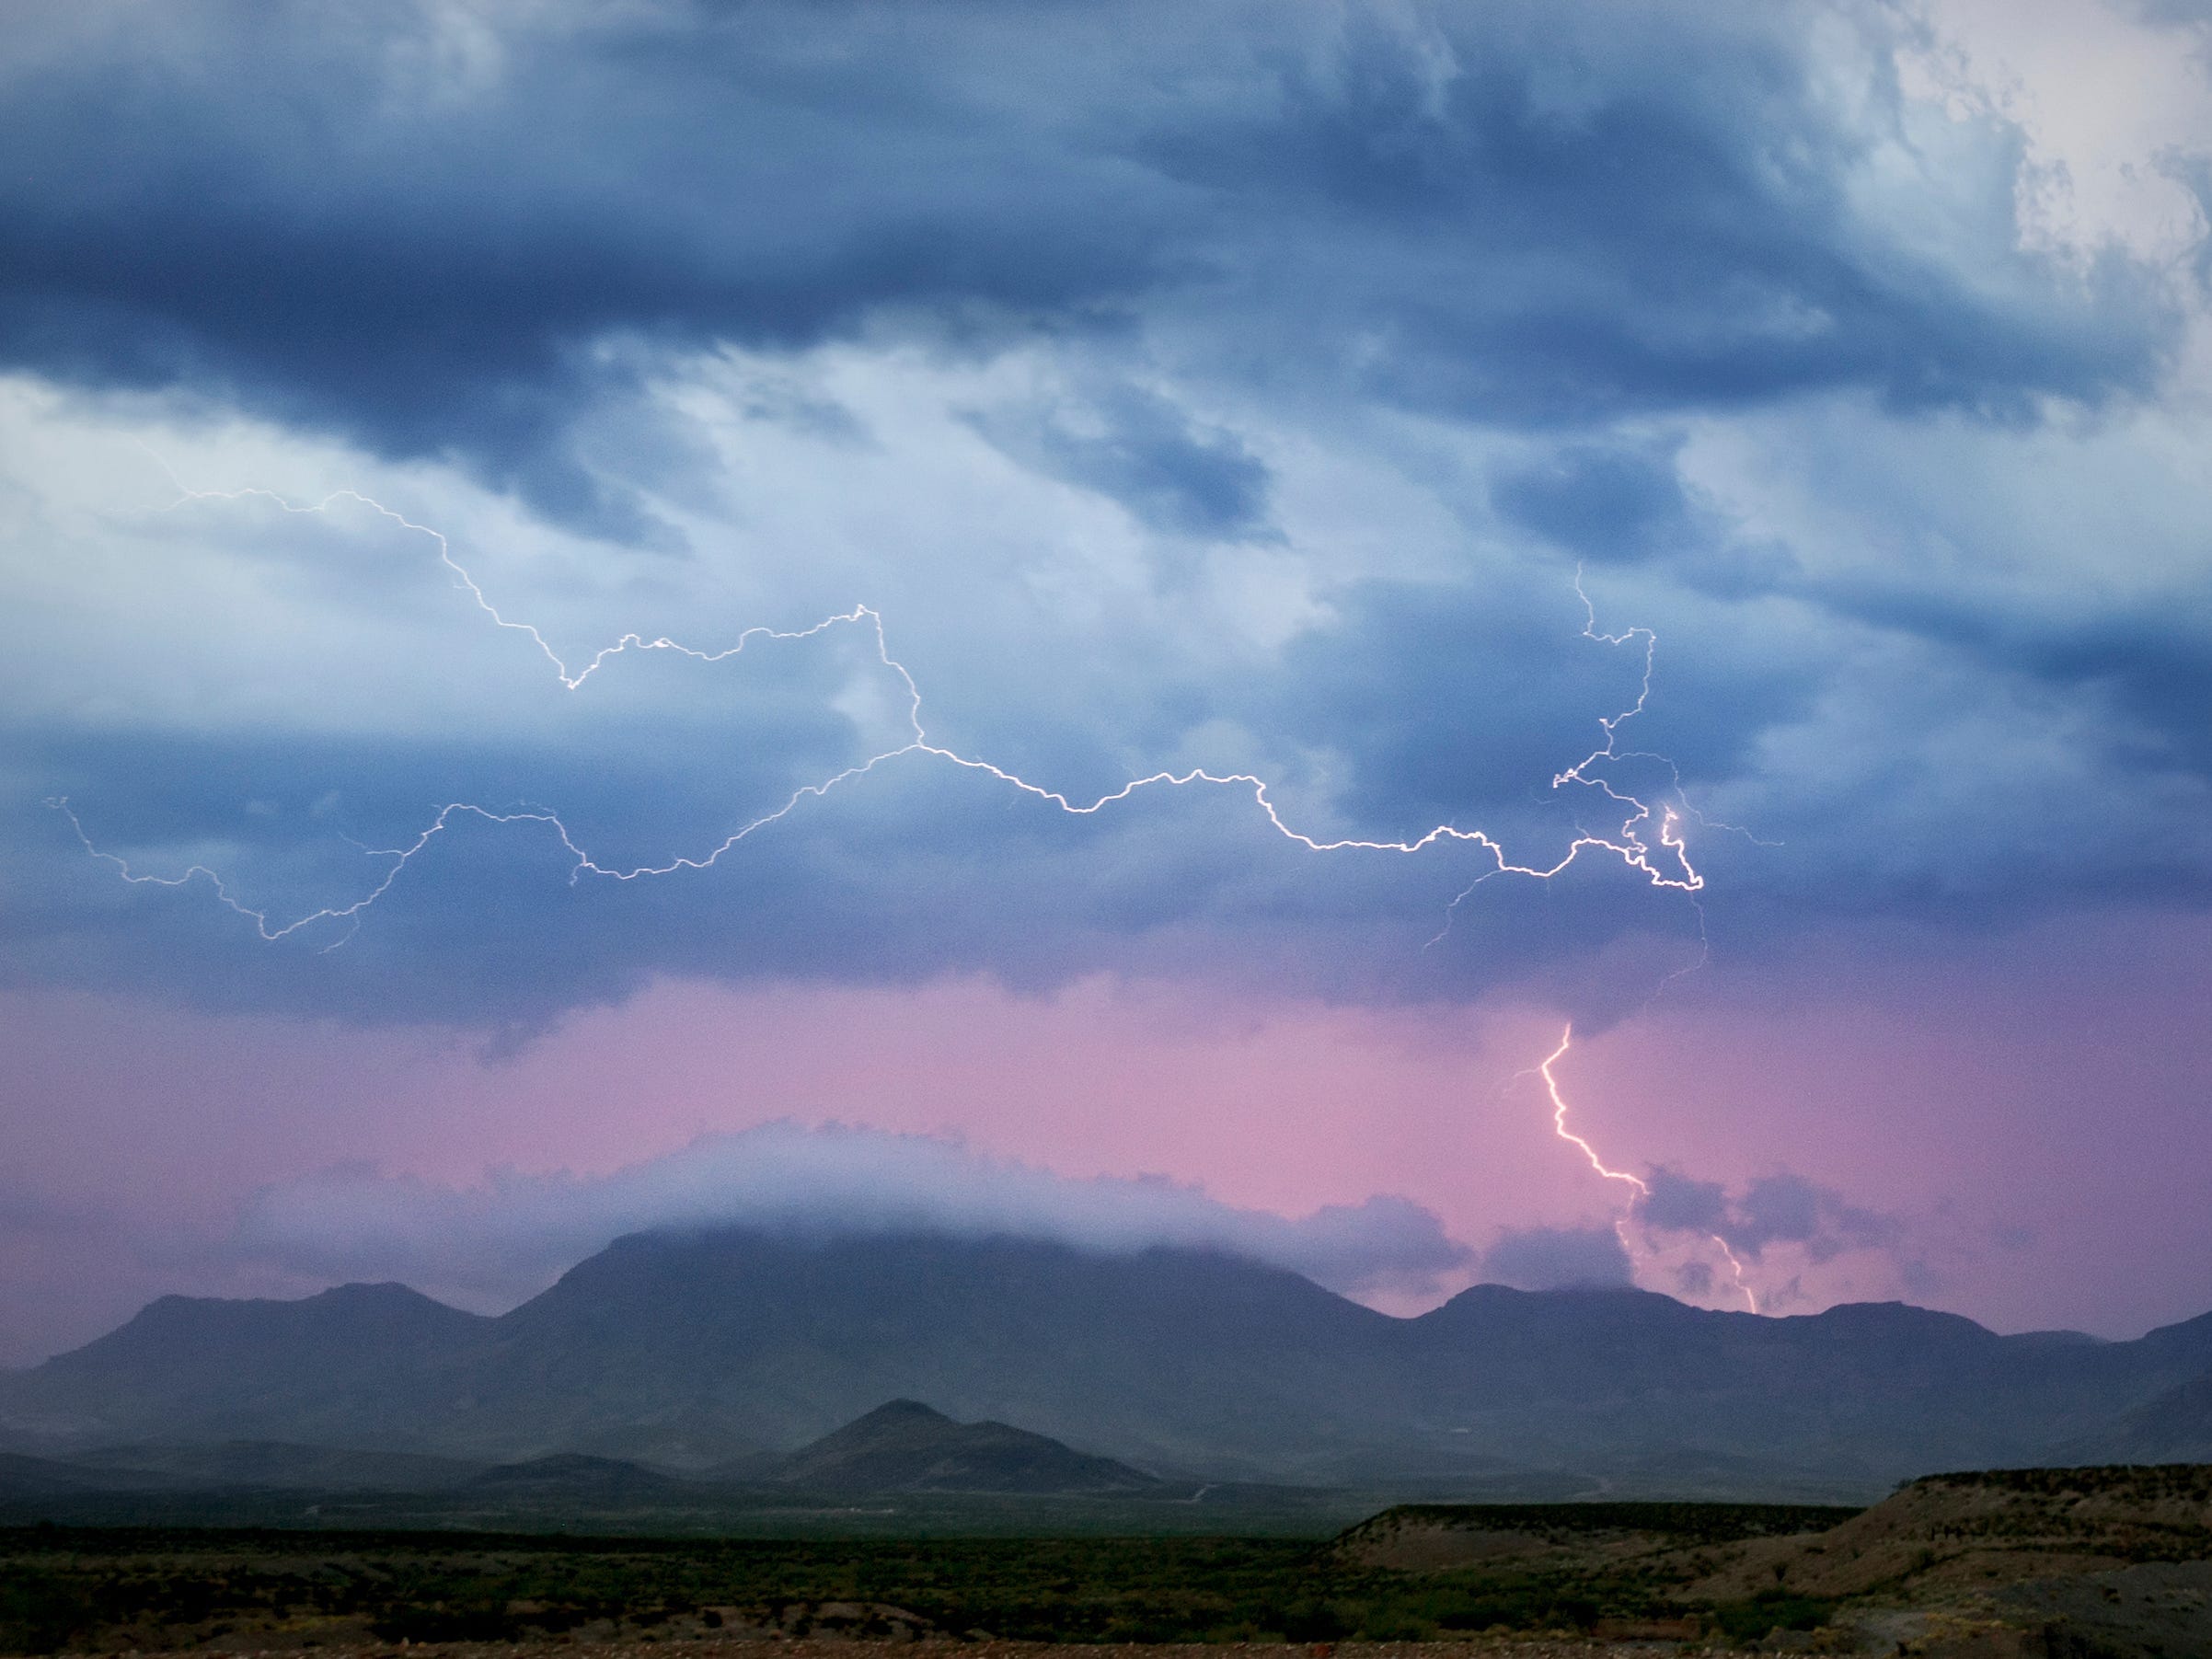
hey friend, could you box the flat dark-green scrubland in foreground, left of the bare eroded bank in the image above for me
[0,1504,1849,1653]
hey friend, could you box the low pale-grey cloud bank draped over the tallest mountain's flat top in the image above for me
[235,1123,1469,1301]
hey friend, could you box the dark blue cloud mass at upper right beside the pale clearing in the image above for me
[1155,5,2166,422]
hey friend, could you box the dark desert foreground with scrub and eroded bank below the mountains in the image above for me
[0,1467,2212,1659]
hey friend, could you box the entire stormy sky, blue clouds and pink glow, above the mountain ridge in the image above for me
[0,0,2212,1363]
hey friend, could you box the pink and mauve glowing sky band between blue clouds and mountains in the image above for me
[0,902,2212,1360]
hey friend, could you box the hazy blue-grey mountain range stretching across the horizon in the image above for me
[0,1230,2212,1500]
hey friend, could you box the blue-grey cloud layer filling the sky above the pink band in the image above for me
[0,0,2212,1035]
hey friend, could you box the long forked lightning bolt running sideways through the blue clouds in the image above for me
[46,479,1705,946]
